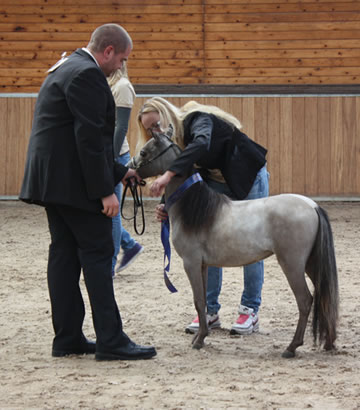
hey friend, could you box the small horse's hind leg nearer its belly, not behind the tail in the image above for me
[279,261,313,358]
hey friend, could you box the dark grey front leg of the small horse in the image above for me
[184,261,209,349]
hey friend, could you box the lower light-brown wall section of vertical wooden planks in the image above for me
[0,97,360,198]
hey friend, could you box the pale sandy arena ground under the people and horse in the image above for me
[0,201,360,409]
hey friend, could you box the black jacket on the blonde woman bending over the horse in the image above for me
[169,111,267,199]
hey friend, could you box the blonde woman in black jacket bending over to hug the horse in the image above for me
[138,97,269,334]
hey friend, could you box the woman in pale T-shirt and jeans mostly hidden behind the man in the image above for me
[108,62,144,276]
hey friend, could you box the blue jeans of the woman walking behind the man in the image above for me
[112,152,136,273]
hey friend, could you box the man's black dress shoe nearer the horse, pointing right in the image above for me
[95,342,156,361]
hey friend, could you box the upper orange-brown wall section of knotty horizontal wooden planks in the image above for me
[0,0,360,92]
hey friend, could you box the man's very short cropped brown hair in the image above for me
[88,23,132,54]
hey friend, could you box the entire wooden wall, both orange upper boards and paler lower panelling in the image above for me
[0,0,360,197]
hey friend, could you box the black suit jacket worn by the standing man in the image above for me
[19,49,127,212]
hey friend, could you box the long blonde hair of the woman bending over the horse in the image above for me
[136,97,242,152]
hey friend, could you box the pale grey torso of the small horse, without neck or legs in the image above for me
[173,194,318,266]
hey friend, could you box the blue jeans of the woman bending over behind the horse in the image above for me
[206,165,269,314]
